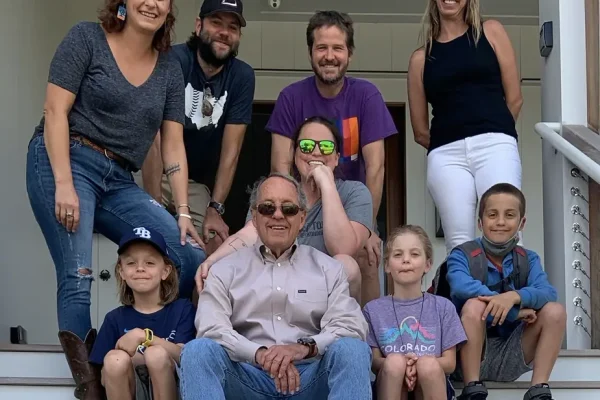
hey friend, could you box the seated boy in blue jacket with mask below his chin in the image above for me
[446,183,567,400]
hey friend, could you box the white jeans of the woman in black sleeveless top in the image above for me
[427,133,521,253]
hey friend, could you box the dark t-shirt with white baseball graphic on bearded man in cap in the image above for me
[171,43,255,190]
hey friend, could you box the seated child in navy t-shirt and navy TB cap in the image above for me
[89,227,196,400]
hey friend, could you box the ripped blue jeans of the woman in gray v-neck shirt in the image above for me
[27,136,206,339]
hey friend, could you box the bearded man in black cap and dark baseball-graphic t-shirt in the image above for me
[142,0,255,256]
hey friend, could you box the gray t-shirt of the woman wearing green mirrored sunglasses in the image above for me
[246,179,373,255]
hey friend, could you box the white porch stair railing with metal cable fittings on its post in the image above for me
[535,122,600,349]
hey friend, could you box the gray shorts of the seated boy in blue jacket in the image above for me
[452,323,532,382]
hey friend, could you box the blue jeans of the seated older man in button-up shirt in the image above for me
[179,338,372,400]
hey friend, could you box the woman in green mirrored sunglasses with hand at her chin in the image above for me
[196,117,373,302]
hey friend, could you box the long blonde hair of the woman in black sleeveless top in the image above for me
[419,0,483,55]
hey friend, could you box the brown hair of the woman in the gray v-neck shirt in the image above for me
[98,0,176,51]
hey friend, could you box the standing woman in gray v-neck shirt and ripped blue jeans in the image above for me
[27,0,205,392]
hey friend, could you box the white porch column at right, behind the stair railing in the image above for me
[539,0,591,349]
